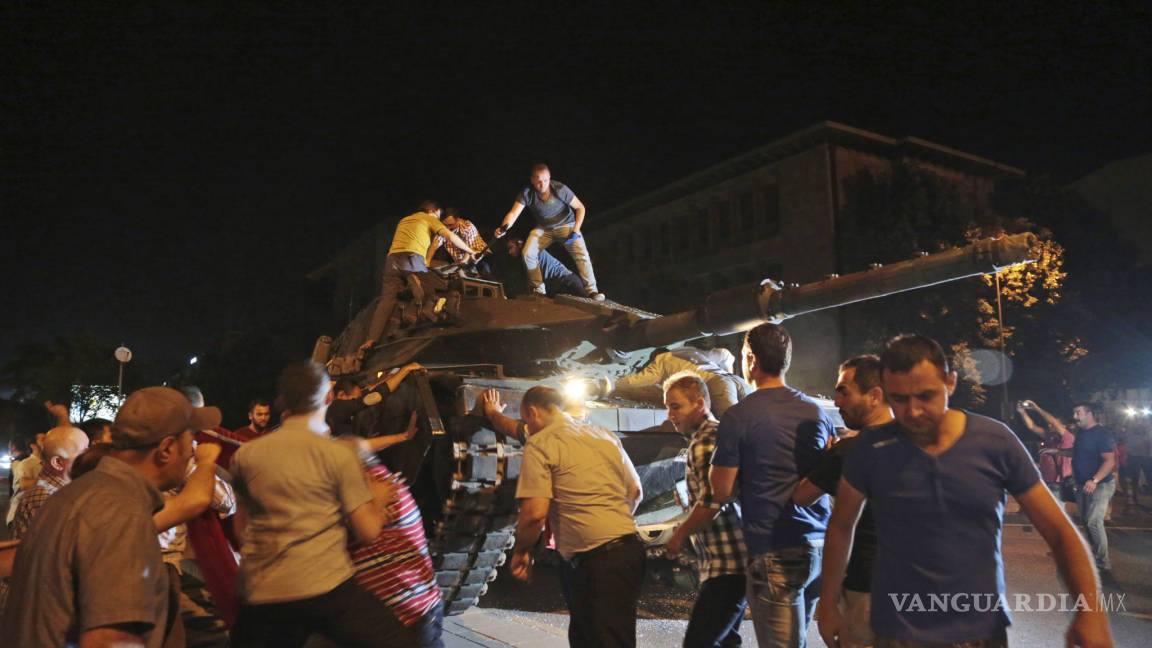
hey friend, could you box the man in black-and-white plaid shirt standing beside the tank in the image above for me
[664,371,748,648]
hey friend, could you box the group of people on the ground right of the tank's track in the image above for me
[482,324,1112,648]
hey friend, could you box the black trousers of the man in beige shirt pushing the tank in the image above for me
[568,536,644,648]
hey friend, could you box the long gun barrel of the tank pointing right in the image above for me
[613,233,1036,351]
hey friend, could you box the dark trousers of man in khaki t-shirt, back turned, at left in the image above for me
[228,579,420,648]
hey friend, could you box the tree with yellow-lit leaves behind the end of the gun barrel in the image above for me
[840,161,1087,414]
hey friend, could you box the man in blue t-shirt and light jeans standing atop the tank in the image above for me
[495,164,604,301]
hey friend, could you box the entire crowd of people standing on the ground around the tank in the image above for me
[0,324,1135,648]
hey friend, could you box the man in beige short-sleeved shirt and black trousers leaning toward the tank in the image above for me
[511,386,644,647]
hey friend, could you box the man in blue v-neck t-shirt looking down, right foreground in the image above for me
[818,334,1112,648]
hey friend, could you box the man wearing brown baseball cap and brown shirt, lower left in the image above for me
[0,387,220,648]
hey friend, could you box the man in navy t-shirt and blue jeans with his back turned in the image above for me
[708,324,833,648]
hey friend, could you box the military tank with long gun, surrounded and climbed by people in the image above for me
[313,233,1034,615]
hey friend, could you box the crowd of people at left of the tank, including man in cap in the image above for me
[0,362,442,647]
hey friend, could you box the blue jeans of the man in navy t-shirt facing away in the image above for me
[748,544,824,648]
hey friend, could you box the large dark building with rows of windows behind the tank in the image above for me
[588,122,1023,393]
